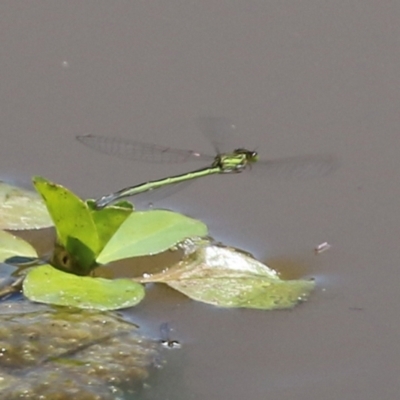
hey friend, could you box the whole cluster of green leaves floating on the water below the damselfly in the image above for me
[0,177,314,310]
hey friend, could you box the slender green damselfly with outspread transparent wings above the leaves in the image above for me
[77,117,336,208]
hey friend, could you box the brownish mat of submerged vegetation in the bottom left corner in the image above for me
[0,301,159,400]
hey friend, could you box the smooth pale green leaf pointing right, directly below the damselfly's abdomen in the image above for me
[97,210,207,264]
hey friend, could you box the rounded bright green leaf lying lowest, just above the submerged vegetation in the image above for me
[23,265,145,311]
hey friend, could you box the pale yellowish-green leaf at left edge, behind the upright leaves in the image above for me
[0,181,53,230]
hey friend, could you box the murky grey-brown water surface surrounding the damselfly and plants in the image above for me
[0,0,400,400]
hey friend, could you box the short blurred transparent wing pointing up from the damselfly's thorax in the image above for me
[197,116,244,154]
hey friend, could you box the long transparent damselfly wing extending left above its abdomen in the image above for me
[76,135,215,163]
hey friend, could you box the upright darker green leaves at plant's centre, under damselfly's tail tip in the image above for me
[33,177,132,275]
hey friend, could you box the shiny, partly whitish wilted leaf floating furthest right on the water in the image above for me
[138,238,315,310]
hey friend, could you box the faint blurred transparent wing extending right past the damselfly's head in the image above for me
[252,154,339,179]
